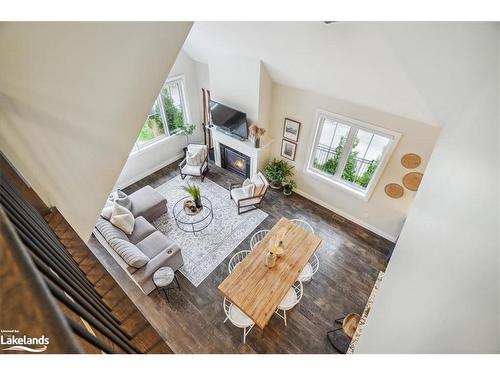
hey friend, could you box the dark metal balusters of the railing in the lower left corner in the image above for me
[0,176,140,353]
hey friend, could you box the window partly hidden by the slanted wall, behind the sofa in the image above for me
[132,77,189,152]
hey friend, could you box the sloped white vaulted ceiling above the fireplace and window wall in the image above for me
[184,22,498,126]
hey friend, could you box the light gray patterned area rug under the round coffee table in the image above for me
[153,176,267,287]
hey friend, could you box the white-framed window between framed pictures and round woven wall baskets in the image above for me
[307,111,399,199]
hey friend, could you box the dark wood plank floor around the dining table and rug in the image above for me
[89,163,394,353]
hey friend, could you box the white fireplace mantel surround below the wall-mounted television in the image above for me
[211,126,272,177]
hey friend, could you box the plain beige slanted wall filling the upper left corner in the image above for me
[0,22,191,240]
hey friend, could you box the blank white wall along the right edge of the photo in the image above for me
[356,24,500,353]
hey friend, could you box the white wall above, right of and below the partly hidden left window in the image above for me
[114,51,203,188]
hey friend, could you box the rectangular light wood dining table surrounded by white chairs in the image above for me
[218,217,321,328]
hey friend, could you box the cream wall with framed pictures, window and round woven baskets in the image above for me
[271,84,440,241]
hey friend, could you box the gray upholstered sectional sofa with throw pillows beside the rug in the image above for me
[94,186,184,294]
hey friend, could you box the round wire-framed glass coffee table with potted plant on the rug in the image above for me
[173,195,214,234]
